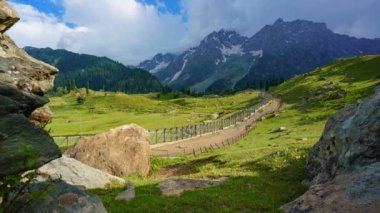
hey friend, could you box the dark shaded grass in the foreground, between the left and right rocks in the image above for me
[91,149,306,212]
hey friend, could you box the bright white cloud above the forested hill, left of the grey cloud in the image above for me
[60,0,186,64]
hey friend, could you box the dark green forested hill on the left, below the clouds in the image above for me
[24,47,162,93]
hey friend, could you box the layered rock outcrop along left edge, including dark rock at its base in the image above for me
[0,0,107,213]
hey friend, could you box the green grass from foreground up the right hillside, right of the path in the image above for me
[88,56,380,212]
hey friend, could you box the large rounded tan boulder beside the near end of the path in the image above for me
[66,124,150,176]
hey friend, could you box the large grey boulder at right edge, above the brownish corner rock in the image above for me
[307,93,380,184]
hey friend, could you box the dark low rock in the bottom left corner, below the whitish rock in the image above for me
[8,182,107,213]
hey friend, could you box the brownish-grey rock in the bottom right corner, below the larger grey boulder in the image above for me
[282,163,380,213]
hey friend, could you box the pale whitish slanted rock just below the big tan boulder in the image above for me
[37,156,125,189]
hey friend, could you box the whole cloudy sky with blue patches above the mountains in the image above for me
[8,0,380,65]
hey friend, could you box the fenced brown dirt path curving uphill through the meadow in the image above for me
[151,98,281,156]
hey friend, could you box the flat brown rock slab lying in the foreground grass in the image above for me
[158,178,227,196]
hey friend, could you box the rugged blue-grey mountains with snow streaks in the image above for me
[138,19,380,91]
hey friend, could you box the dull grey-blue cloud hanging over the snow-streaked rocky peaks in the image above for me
[183,0,380,39]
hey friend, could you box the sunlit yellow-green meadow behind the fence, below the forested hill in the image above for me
[47,91,259,135]
